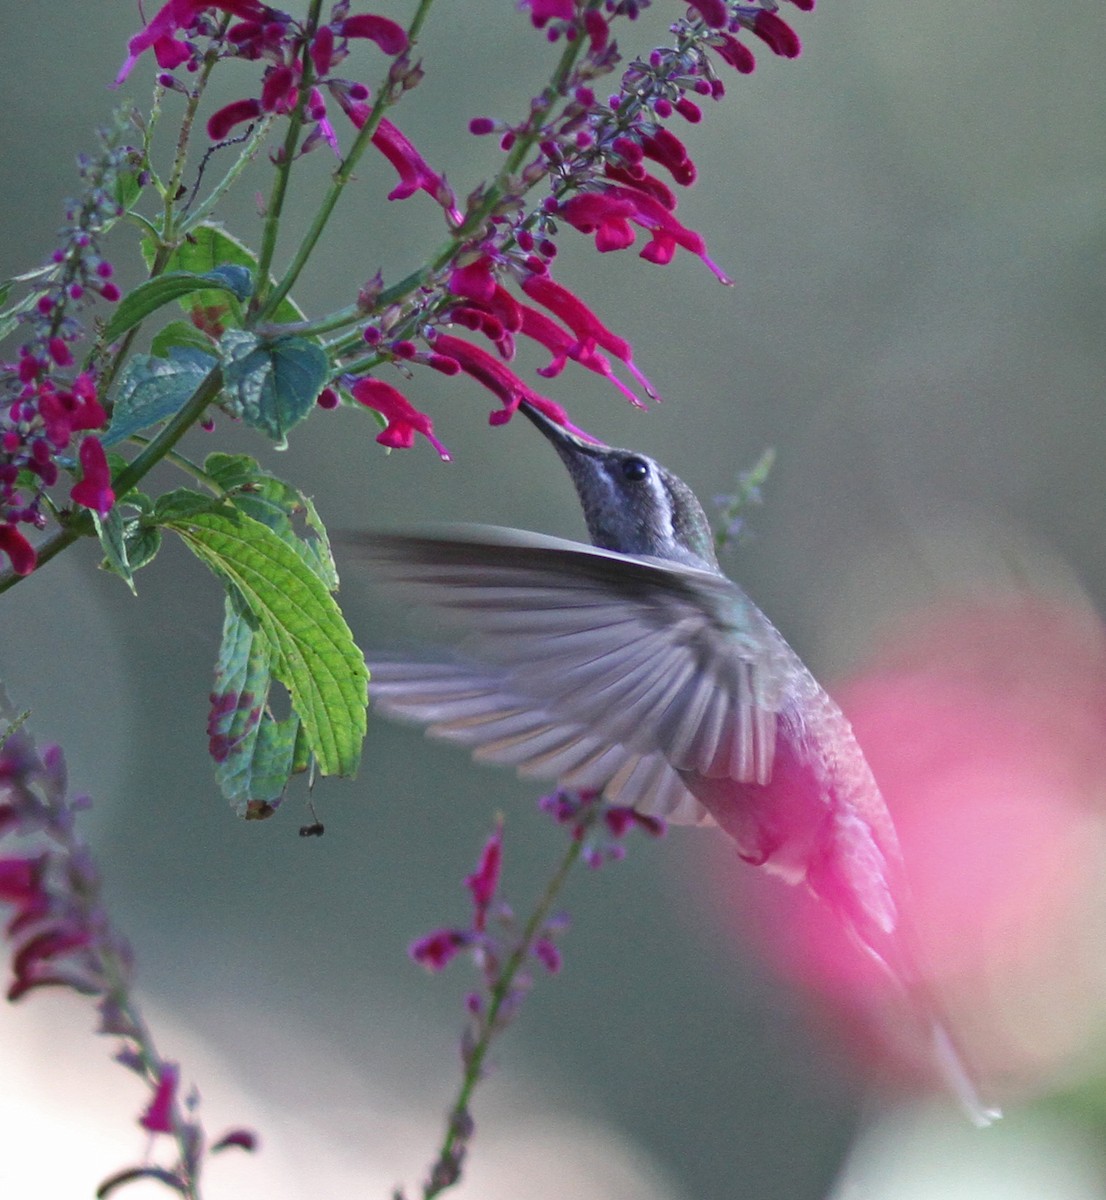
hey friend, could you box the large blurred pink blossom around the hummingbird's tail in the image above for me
[700,594,1106,1098]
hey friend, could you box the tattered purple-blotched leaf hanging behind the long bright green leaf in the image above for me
[208,599,300,817]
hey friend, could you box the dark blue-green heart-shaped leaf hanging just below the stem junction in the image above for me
[222,329,329,448]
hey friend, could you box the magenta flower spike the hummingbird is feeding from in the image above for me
[331,0,813,457]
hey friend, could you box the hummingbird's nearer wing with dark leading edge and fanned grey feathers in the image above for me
[354,528,803,792]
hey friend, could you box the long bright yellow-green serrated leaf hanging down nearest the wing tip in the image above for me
[164,504,368,775]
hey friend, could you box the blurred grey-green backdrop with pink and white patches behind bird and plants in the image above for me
[0,0,1106,1200]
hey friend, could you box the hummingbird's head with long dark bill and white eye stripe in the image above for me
[519,402,719,572]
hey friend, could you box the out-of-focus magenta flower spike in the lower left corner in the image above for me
[0,710,252,1195]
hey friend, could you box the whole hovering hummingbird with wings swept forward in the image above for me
[357,401,997,1123]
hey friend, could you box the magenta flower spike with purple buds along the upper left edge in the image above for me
[0,130,134,575]
